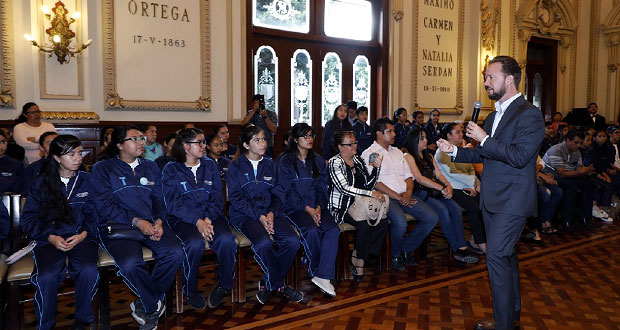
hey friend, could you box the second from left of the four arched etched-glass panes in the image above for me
[291,49,312,126]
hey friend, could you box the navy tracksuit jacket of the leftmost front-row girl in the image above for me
[21,171,97,244]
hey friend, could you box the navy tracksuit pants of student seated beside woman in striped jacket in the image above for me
[289,209,340,280]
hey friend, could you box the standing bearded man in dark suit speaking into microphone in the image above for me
[438,56,545,330]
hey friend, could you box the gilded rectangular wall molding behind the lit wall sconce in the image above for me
[37,0,84,100]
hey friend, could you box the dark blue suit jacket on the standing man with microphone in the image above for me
[454,96,545,217]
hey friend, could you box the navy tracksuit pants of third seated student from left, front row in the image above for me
[172,217,237,297]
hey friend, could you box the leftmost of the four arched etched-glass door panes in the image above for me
[254,46,278,113]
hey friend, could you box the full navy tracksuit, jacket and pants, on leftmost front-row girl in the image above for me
[21,171,99,329]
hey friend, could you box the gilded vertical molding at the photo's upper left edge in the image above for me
[0,0,15,108]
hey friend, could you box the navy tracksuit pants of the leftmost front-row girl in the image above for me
[30,237,99,330]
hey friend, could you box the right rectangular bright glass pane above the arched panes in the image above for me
[325,0,373,40]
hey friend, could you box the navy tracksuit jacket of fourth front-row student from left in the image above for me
[226,155,282,226]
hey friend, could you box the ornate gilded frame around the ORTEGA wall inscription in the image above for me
[102,0,211,111]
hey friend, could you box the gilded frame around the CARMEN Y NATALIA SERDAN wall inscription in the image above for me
[411,0,465,115]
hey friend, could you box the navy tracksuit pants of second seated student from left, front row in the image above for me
[99,225,184,314]
